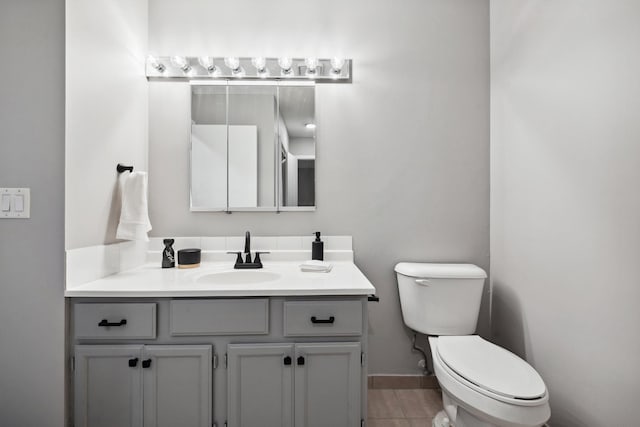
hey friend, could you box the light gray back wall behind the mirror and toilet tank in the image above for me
[149,0,489,374]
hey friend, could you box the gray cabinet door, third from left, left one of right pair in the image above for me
[227,344,295,427]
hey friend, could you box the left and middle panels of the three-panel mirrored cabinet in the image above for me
[191,85,277,211]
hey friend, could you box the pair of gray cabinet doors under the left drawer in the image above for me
[74,345,212,427]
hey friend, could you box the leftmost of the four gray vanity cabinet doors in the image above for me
[74,345,142,427]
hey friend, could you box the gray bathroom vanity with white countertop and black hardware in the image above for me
[66,254,375,427]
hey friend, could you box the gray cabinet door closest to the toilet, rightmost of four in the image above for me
[294,342,362,427]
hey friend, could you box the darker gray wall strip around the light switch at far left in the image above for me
[0,0,65,427]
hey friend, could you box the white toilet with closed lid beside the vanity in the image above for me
[395,262,551,427]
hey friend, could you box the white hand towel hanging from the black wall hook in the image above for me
[116,172,151,242]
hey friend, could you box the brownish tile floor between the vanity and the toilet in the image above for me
[367,389,442,427]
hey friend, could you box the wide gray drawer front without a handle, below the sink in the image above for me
[169,298,269,336]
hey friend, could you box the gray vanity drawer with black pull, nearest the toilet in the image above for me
[284,301,362,337]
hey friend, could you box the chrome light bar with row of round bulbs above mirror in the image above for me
[145,55,353,84]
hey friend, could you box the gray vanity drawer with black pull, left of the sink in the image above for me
[74,303,156,340]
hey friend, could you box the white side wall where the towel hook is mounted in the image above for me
[65,0,148,249]
